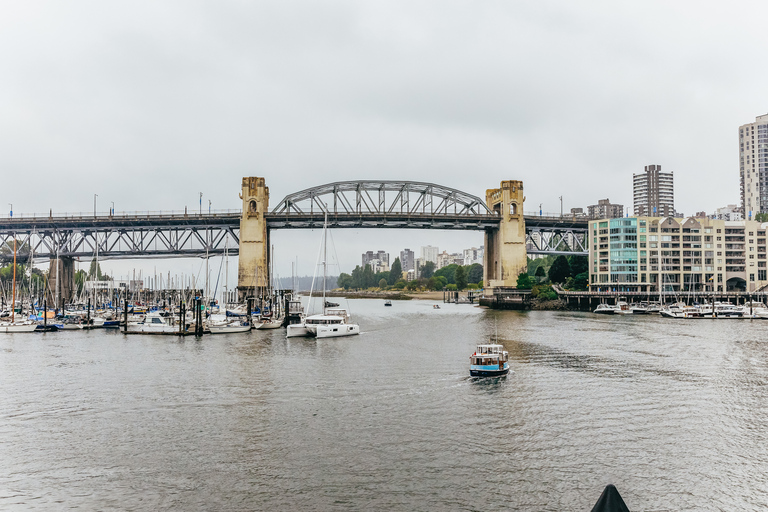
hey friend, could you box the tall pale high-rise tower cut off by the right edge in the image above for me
[739,114,768,220]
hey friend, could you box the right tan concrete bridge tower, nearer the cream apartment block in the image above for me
[483,180,528,289]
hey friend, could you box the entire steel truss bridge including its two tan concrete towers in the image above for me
[0,178,587,302]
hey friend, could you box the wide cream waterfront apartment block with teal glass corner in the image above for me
[589,216,768,294]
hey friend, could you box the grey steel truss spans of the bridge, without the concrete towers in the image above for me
[0,180,587,262]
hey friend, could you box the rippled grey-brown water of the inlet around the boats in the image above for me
[0,300,768,511]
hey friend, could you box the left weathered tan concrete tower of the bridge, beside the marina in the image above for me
[237,178,269,302]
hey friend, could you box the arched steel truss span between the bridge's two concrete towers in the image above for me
[265,180,499,230]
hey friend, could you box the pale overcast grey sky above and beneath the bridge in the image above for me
[0,0,768,288]
